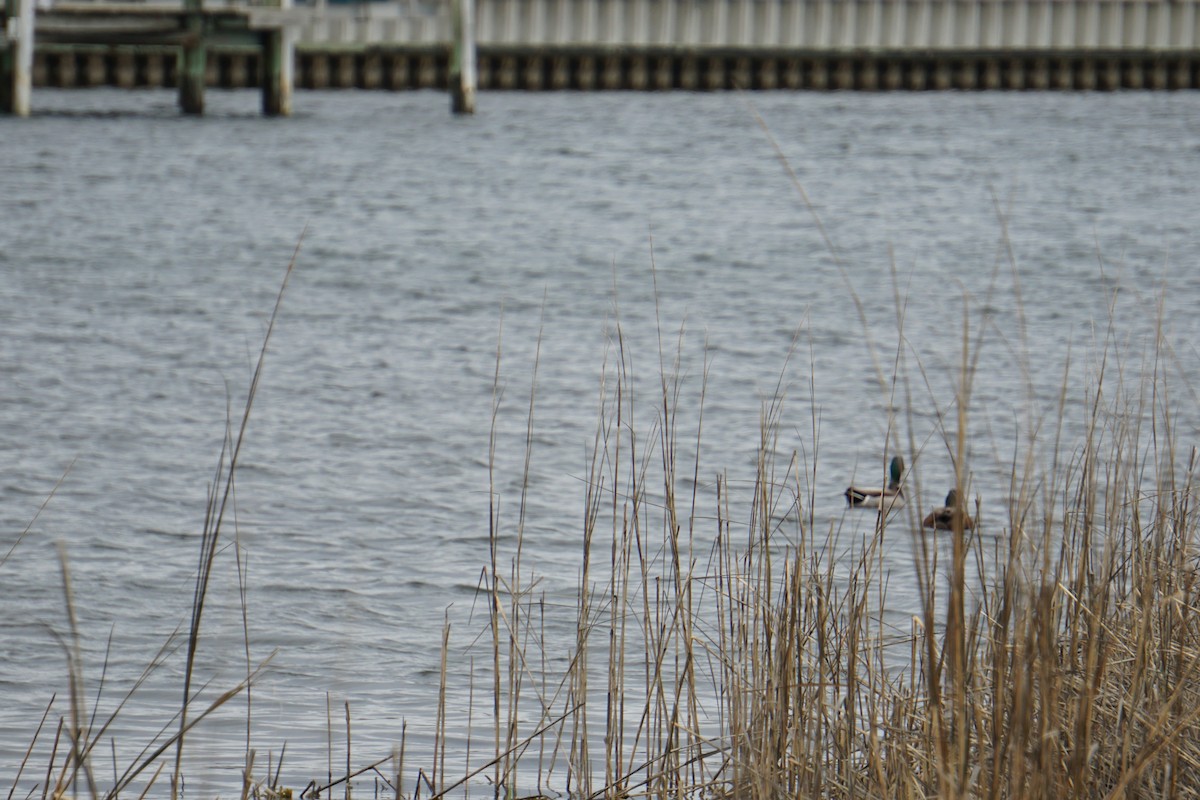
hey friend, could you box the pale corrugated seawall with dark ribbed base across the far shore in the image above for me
[7,0,1200,100]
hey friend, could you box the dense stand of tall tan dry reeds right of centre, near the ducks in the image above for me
[448,280,1200,799]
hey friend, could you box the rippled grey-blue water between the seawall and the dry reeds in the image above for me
[0,90,1200,796]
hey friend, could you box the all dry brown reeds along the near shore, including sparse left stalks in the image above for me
[9,145,1200,800]
